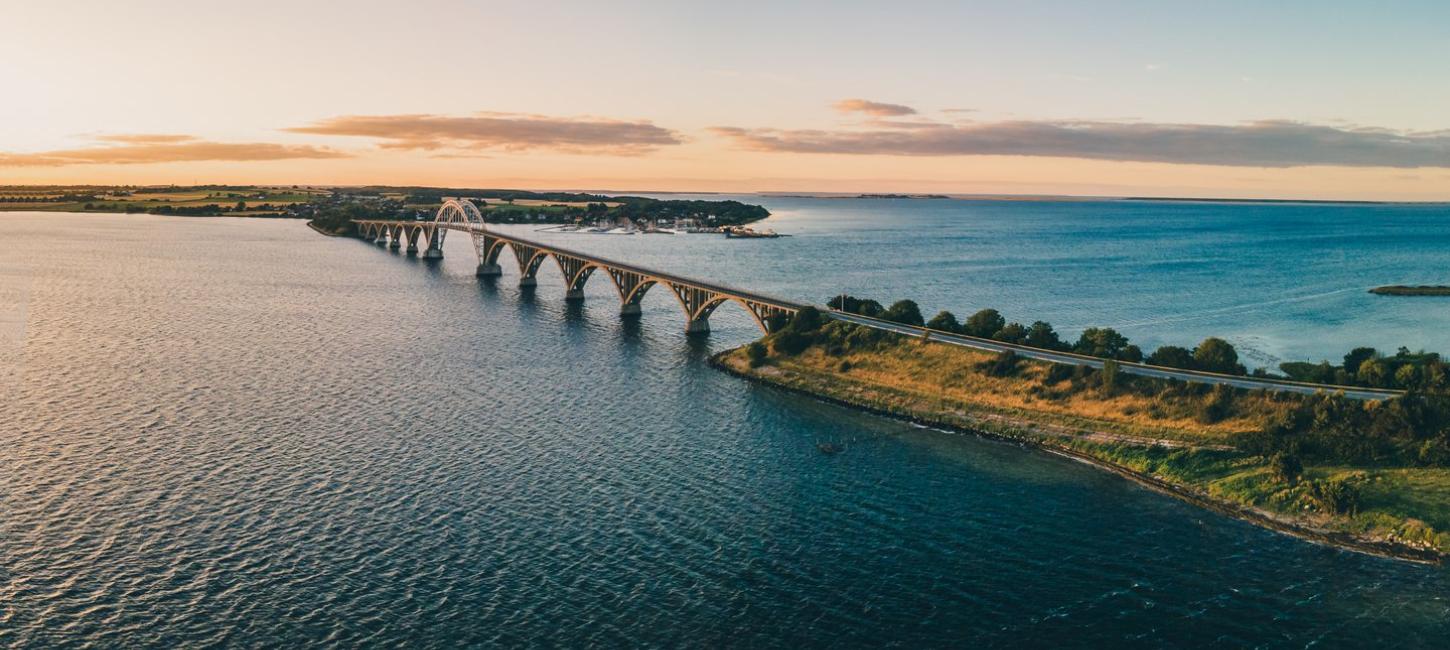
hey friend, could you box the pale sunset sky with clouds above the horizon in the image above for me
[0,0,1450,200]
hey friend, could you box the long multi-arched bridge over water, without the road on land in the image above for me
[354,199,805,334]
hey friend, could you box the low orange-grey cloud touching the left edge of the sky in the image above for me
[0,133,348,167]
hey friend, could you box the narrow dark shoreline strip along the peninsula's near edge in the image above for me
[709,348,1450,566]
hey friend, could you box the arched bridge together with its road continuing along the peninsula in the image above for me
[345,199,1405,399]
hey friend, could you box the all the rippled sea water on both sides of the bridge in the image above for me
[0,199,1450,647]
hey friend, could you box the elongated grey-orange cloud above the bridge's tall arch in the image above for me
[286,113,683,155]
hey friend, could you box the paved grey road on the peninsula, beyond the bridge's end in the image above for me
[827,310,1404,399]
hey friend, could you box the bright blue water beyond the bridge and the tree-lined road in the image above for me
[513,196,1450,369]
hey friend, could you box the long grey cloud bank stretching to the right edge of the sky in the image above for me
[711,120,1450,168]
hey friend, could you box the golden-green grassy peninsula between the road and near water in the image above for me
[713,309,1450,563]
